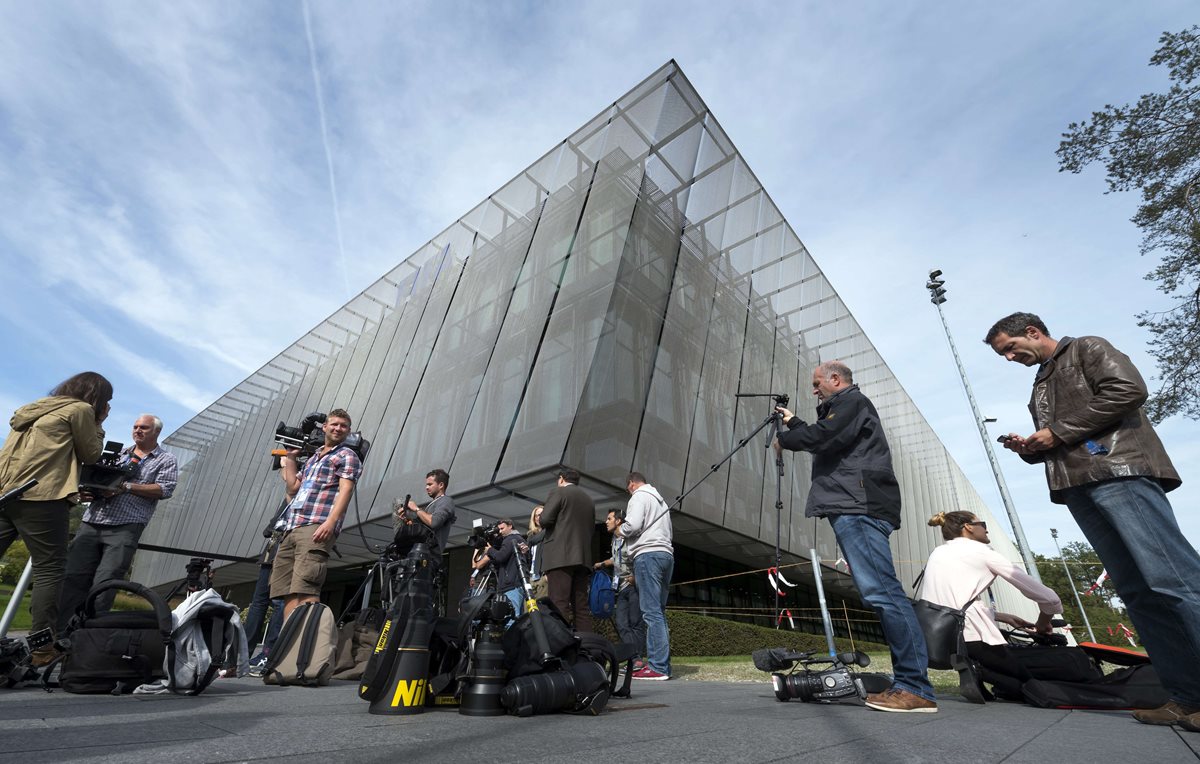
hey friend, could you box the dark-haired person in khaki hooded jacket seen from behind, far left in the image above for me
[0,372,113,642]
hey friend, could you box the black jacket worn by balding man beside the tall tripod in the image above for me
[779,385,900,528]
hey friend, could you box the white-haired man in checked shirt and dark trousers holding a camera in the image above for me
[59,414,179,633]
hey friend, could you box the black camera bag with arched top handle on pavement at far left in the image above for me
[42,579,175,694]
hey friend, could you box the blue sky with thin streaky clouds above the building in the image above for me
[0,0,1200,557]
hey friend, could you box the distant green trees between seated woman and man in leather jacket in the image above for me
[1034,541,1141,648]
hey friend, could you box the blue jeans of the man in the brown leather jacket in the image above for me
[1062,477,1200,706]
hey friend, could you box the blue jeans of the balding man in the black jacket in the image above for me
[829,515,935,700]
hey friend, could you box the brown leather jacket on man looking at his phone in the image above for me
[1021,337,1182,504]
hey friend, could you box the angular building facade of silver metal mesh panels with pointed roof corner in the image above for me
[136,62,1022,612]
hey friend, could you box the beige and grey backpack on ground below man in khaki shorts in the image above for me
[263,602,337,687]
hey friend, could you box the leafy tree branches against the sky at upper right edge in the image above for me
[1057,26,1200,422]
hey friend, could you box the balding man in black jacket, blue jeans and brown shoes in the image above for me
[775,361,937,714]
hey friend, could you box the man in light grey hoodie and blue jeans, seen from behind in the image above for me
[617,473,674,681]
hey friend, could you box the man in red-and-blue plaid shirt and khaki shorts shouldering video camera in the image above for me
[271,409,362,621]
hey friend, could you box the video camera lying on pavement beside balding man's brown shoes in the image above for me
[752,648,871,703]
